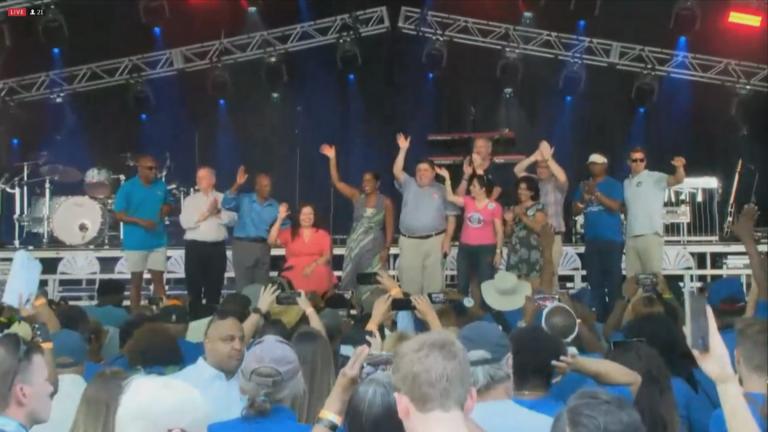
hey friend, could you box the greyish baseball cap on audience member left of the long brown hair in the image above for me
[240,335,301,394]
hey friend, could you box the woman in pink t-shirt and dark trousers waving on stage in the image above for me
[437,167,504,296]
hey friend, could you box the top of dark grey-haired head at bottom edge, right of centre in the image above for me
[552,390,646,432]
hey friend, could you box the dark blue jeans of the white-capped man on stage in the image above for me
[583,240,624,322]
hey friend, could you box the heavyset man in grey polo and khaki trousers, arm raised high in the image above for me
[392,134,458,294]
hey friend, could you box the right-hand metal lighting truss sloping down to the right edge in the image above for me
[398,7,768,91]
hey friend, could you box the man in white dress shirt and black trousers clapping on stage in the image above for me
[179,166,237,317]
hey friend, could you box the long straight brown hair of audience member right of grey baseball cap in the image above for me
[291,327,336,423]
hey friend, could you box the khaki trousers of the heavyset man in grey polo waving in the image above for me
[397,234,445,294]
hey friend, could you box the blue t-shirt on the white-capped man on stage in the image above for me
[573,177,624,242]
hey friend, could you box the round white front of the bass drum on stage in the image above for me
[51,196,106,246]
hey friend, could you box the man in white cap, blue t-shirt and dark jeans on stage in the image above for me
[573,153,624,322]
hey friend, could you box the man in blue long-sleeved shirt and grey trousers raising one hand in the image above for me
[221,166,288,292]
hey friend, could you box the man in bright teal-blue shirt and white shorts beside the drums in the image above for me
[114,155,171,307]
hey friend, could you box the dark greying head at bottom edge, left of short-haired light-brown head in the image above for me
[344,372,405,432]
